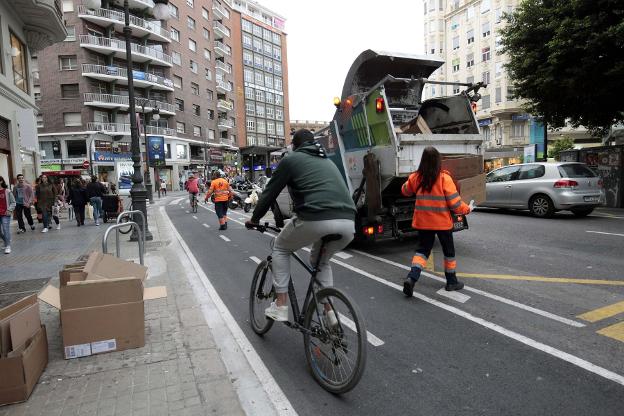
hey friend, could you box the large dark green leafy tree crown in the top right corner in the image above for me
[500,0,624,135]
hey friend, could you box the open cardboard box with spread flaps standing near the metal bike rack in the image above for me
[39,252,167,359]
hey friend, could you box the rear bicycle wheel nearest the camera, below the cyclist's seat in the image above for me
[303,287,366,394]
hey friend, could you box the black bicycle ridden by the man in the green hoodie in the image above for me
[249,223,367,394]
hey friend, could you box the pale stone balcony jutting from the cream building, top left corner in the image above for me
[12,0,67,53]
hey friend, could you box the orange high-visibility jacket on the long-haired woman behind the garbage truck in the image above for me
[401,170,470,230]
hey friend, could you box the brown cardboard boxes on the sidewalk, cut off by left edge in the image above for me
[0,295,48,405]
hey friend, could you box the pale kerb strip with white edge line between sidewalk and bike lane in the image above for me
[161,207,297,416]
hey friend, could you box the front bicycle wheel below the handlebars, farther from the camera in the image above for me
[249,260,275,335]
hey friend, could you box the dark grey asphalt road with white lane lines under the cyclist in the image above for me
[166,198,624,415]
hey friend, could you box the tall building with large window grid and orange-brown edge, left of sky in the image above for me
[231,0,290,179]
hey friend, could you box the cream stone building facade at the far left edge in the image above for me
[0,0,66,182]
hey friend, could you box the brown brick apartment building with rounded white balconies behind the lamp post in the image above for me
[34,0,237,190]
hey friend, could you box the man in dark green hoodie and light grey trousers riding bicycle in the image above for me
[245,129,355,324]
